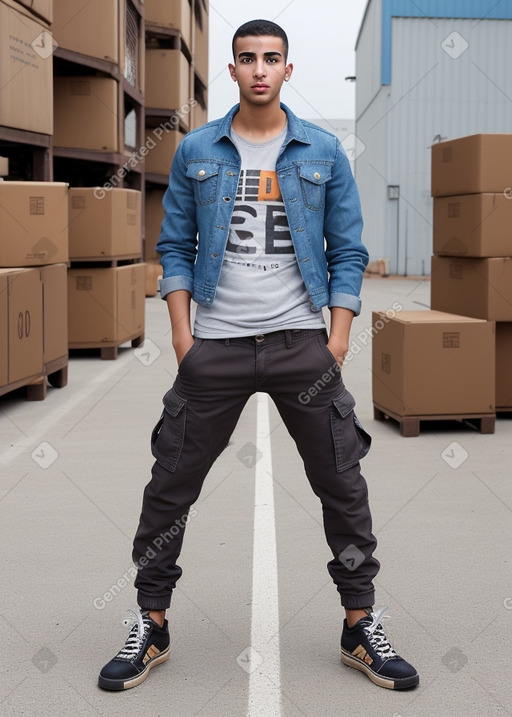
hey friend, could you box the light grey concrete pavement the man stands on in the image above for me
[0,278,512,717]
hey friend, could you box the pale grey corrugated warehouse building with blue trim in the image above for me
[354,0,512,275]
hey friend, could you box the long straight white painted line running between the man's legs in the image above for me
[247,393,281,717]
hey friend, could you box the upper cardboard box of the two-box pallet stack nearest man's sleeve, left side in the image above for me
[69,187,142,260]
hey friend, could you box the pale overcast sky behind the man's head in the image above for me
[208,0,367,119]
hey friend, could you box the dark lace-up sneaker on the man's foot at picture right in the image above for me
[341,607,420,690]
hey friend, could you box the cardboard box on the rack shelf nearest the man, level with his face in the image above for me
[146,48,190,110]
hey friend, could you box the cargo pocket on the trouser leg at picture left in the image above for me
[151,388,187,473]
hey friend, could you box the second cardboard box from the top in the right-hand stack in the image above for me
[434,193,512,257]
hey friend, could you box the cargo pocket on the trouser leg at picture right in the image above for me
[331,391,372,473]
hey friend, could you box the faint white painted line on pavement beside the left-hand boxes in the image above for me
[0,352,133,465]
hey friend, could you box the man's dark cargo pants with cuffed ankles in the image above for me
[133,329,379,610]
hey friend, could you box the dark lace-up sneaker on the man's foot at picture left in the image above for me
[98,610,169,690]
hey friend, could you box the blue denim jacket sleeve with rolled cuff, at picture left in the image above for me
[156,138,197,299]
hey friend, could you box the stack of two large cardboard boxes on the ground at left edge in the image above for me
[0,181,68,399]
